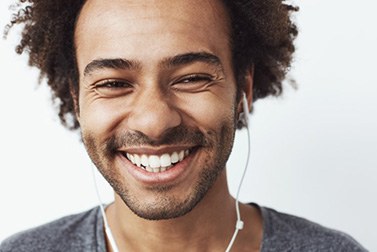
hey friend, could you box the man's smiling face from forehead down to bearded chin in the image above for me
[75,0,236,219]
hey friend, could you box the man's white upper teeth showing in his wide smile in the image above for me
[126,150,189,172]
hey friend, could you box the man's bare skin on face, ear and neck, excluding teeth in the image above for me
[75,0,262,251]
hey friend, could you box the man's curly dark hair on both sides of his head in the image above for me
[4,0,298,129]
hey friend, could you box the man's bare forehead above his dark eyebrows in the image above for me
[75,0,230,74]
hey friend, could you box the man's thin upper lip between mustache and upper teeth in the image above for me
[118,145,195,155]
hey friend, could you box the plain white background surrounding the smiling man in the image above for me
[0,0,377,251]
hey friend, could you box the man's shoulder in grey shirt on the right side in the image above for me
[261,207,367,252]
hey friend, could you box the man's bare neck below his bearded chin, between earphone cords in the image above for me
[106,171,260,251]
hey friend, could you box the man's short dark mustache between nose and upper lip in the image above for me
[105,126,210,154]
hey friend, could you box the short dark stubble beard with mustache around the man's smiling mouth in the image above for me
[82,120,235,220]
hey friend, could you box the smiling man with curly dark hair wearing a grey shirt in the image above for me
[0,0,365,251]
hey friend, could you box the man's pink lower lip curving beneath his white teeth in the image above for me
[118,151,196,185]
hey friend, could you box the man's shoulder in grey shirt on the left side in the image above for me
[0,208,102,252]
